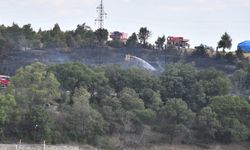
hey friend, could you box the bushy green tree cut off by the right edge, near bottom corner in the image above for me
[209,96,250,143]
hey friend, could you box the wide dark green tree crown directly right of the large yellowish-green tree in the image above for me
[50,63,108,96]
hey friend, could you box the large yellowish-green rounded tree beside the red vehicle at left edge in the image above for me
[9,62,60,111]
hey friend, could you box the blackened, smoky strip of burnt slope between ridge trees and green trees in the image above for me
[0,47,236,75]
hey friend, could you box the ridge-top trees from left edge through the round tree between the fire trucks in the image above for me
[0,23,151,53]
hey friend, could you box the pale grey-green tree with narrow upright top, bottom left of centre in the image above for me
[62,87,104,144]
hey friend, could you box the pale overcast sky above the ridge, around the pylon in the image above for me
[0,0,250,50]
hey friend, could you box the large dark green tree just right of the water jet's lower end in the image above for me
[160,63,206,111]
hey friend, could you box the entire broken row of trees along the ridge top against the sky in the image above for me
[0,23,243,59]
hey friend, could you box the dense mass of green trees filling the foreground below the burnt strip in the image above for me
[0,63,250,149]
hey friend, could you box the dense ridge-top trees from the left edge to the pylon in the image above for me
[0,23,103,50]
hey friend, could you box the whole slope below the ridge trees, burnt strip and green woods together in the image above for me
[0,47,250,150]
